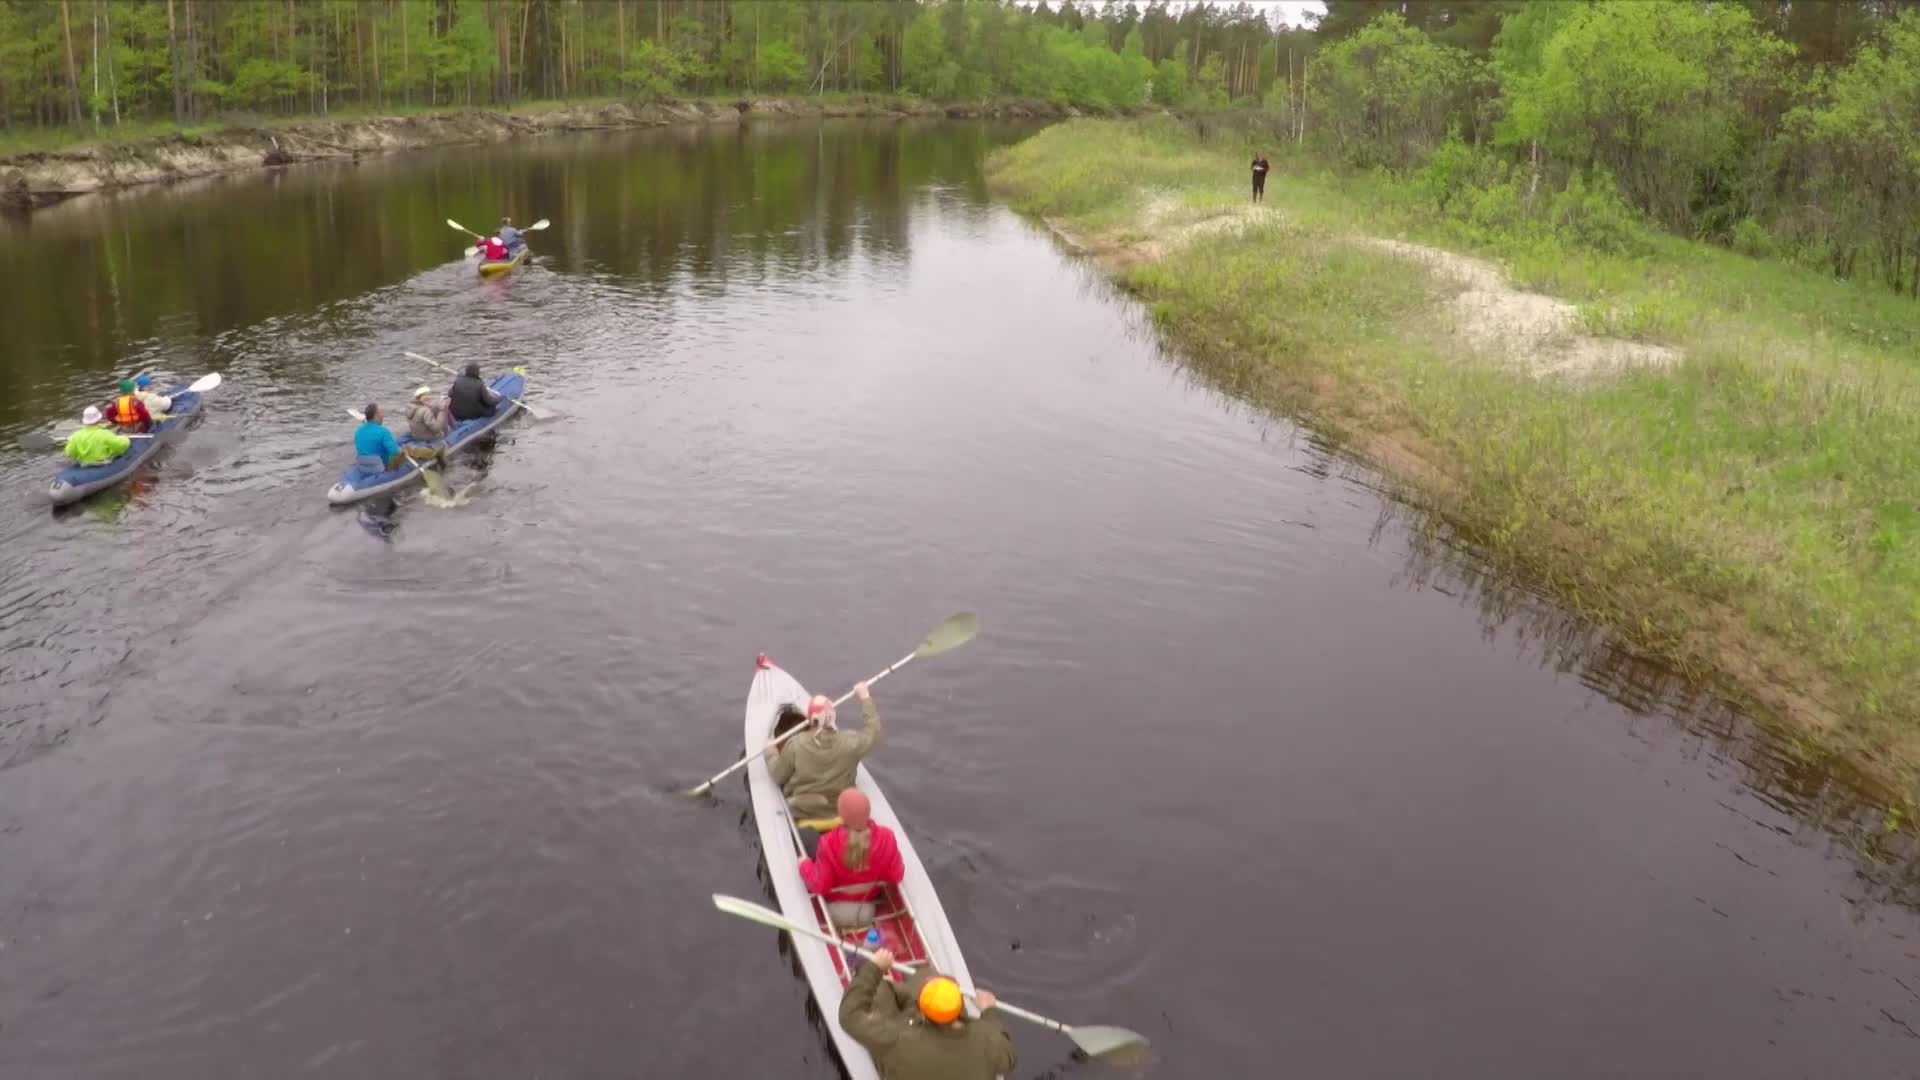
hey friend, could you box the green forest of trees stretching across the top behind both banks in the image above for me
[0,0,1920,298]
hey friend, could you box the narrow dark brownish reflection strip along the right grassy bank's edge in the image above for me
[1059,247,1920,911]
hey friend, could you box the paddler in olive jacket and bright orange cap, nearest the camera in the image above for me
[839,949,1014,1080]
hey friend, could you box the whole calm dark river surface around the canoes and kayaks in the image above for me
[0,121,1920,1080]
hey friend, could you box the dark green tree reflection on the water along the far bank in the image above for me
[0,121,1025,430]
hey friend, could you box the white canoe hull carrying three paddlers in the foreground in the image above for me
[745,657,973,1080]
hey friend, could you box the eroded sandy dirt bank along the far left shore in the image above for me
[0,98,1077,209]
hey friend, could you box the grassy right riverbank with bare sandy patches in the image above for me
[989,121,1920,796]
